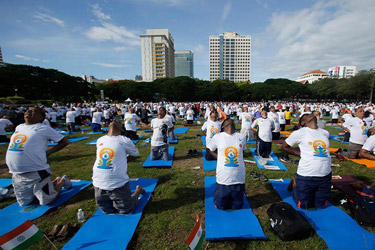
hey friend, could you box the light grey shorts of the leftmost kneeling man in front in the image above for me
[12,169,58,206]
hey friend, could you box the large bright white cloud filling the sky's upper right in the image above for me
[253,0,375,79]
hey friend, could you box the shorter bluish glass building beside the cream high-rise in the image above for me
[174,50,194,78]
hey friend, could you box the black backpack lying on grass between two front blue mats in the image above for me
[267,202,313,240]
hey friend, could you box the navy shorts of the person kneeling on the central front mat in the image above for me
[214,183,245,210]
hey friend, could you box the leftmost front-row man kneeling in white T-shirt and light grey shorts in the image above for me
[6,107,72,206]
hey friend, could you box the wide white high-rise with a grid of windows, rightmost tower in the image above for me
[210,32,251,82]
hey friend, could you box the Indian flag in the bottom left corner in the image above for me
[0,220,43,250]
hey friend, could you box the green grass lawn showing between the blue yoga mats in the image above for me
[0,118,375,250]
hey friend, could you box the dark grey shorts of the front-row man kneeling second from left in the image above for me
[94,182,138,214]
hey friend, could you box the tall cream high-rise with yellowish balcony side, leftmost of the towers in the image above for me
[141,29,175,82]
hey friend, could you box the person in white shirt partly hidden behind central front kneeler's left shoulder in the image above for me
[202,110,221,161]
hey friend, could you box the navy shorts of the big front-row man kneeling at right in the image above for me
[292,173,332,209]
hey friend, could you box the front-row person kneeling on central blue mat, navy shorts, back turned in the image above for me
[208,119,246,210]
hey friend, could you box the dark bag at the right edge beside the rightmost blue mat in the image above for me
[347,195,375,226]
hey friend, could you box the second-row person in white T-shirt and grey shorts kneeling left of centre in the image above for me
[151,107,173,161]
